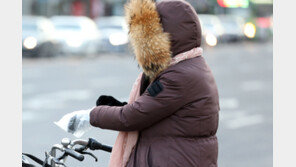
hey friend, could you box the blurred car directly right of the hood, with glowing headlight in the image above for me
[198,14,224,46]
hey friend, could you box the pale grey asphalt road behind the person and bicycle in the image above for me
[22,42,273,167]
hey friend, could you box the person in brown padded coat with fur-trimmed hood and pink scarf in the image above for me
[90,0,219,167]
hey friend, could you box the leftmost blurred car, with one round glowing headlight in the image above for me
[22,16,60,57]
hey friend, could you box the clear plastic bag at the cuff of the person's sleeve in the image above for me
[54,108,93,138]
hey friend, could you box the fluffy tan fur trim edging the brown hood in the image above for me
[125,0,172,80]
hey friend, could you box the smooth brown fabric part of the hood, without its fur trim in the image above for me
[156,0,202,56]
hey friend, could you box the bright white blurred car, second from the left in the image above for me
[51,16,100,55]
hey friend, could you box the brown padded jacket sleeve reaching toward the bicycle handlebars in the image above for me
[90,72,184,131]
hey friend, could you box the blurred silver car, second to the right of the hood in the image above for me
[218,15,245,42]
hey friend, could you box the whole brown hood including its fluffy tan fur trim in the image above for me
[125,0,201,80]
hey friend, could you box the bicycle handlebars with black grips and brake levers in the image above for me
[22,138,112,167]
